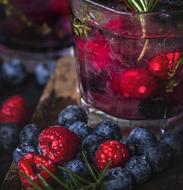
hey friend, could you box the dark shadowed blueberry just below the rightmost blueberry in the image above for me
[144,143,172,173]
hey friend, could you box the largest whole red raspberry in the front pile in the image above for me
[39,125,80,164]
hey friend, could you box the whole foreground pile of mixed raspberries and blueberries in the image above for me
[13,105,183,190]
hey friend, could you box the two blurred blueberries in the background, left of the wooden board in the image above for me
[0,59,55,89]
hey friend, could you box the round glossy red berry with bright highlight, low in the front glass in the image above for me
[119,68,158,99]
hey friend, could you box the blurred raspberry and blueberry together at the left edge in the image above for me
[0,96,31,151]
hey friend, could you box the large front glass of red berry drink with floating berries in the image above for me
[71,0,183,134]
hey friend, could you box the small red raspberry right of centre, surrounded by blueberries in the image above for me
[94,140,129,171]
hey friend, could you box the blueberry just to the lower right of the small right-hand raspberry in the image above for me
[125,156,152,184]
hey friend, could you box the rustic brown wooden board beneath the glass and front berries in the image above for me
[1,57,183,190]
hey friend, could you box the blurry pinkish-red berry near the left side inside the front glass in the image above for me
[86,35,111,72]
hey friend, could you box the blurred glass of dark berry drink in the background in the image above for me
[0,0,72,63]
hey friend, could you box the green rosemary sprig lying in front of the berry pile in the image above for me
[23,152,111,190]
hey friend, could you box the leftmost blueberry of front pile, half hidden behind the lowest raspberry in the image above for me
[13,146,37,163]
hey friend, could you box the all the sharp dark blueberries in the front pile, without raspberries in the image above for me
[13,105,183,190]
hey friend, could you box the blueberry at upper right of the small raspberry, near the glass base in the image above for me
[127,128,157,146]
